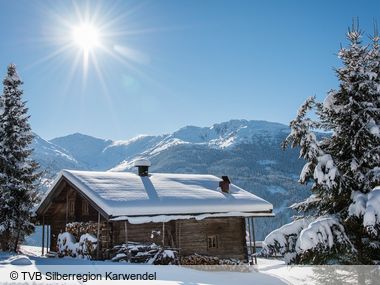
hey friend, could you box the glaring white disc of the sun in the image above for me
[72,23,100,53]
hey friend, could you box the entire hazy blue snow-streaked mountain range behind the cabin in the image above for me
[33,120,308,240]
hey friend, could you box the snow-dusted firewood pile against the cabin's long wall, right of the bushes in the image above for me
[110,242,178,265]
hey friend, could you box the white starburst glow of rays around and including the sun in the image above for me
[29,2,154,93]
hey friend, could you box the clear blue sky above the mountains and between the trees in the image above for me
[0,0,380,139]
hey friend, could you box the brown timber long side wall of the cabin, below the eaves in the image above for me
[112,217,247,260]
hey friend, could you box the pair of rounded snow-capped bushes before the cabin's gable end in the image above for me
[57,232,97,259]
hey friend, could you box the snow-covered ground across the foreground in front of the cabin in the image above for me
[0,243,380,285]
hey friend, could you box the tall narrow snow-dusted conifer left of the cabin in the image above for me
[0,64,39,251]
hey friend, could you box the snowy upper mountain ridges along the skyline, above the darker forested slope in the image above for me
[35,120,288,171]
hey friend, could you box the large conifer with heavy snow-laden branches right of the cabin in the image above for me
[263,22,380,264]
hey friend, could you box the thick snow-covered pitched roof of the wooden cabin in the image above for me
[41,170,273,217]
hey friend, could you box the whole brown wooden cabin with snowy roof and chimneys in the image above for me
[37,161,273,261]
